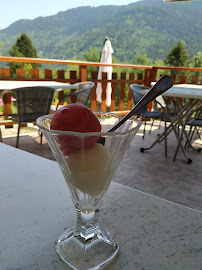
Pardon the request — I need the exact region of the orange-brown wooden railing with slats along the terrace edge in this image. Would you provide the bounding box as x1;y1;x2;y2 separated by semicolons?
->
0;56;202;127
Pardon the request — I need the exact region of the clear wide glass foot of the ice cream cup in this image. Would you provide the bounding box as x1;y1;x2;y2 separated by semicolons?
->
56;226;119;270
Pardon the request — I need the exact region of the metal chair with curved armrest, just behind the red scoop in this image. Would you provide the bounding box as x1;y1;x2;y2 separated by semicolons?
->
52;81;95;111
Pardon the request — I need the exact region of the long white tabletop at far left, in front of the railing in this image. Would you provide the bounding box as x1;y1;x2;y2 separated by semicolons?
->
0;80;78;91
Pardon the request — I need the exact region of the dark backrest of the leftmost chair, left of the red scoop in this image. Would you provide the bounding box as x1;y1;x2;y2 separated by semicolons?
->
12;86;54;122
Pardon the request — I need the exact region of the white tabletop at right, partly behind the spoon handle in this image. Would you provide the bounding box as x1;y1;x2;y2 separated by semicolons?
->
145;83;202;99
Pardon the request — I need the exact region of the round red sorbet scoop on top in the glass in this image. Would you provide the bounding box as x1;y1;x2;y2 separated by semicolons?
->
50;103;101;156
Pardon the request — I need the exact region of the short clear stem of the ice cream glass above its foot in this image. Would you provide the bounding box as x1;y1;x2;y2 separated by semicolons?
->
76;210;99;242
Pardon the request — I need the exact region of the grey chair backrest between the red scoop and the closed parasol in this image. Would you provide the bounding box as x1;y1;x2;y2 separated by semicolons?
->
76;82;95;105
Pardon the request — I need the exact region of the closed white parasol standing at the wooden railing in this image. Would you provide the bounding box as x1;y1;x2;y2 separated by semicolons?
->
96;37;114;106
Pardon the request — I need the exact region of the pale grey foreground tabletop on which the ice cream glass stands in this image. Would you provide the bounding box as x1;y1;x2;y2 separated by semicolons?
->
0;143;202;270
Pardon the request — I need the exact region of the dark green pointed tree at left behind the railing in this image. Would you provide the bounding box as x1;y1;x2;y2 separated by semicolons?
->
9;34;41;76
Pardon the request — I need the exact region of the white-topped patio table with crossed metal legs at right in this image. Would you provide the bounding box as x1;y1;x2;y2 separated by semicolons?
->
140;82;202;163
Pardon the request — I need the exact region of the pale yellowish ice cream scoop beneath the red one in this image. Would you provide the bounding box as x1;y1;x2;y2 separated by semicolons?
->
67;143;113;196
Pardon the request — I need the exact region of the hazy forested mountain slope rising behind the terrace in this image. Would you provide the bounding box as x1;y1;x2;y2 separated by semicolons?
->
0;0;202;63
